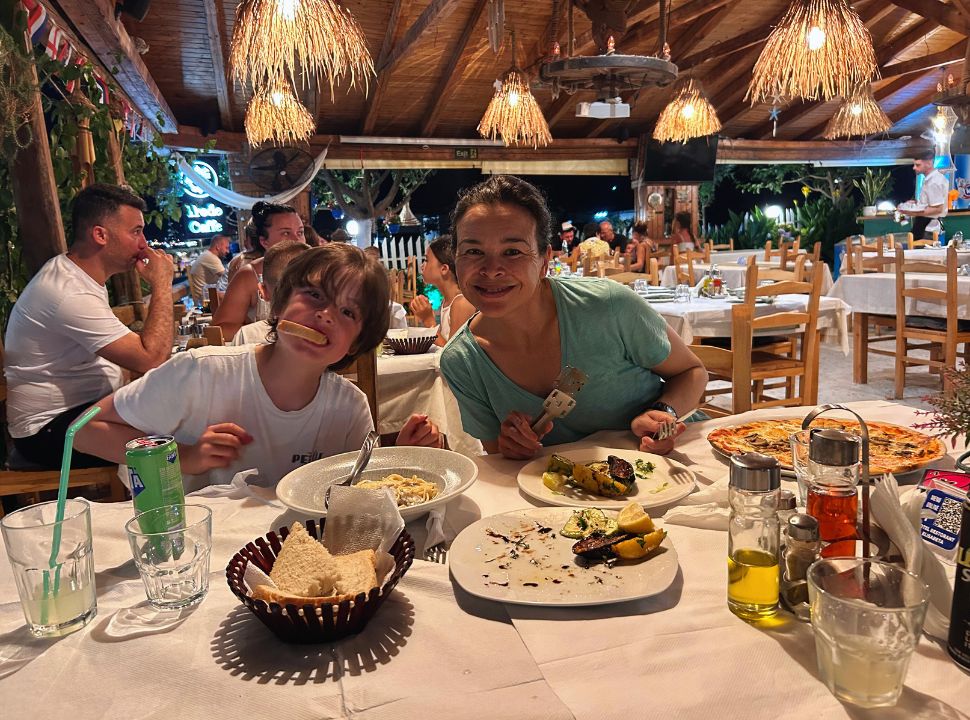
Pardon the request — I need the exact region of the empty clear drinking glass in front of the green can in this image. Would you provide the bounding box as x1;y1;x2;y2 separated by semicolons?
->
125;505;212;610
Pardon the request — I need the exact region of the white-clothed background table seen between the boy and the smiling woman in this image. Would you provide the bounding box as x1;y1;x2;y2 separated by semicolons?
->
377;349;484;456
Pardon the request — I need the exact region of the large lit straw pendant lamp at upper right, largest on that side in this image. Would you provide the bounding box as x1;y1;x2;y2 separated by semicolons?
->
745;0;879;105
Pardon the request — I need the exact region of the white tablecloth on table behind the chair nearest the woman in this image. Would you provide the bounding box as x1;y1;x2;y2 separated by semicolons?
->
650;295;849;355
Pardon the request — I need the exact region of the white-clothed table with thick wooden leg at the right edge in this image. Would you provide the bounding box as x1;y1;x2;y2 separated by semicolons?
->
827;272;970;384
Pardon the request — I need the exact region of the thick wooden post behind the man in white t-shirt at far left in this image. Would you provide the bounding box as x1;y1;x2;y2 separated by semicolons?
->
10;56;67;275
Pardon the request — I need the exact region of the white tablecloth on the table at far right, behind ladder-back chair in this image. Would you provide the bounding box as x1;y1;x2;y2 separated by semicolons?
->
828;273;970;320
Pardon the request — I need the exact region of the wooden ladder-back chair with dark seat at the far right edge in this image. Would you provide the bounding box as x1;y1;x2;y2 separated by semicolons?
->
894;247;970;398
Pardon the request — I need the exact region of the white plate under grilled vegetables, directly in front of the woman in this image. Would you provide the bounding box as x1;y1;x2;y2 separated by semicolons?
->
518;447;697;508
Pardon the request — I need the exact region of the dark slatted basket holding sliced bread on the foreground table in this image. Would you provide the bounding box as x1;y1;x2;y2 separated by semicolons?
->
226;519;414;643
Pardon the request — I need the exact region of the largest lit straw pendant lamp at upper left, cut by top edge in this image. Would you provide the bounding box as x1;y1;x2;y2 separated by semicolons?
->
229;0;376;96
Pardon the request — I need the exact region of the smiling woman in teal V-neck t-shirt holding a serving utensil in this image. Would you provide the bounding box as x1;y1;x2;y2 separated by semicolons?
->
441;175;707;459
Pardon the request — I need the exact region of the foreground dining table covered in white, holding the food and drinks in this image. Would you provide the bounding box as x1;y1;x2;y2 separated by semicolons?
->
0;401;970;720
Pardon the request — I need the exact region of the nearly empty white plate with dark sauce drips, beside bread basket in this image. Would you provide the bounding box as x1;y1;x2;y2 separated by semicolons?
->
448;507;678;607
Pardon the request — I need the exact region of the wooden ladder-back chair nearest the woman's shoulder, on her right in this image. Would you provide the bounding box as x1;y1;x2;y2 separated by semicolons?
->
691;262;822;413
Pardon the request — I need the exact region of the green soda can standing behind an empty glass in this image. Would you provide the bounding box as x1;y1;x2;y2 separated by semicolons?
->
125;435;185;544
